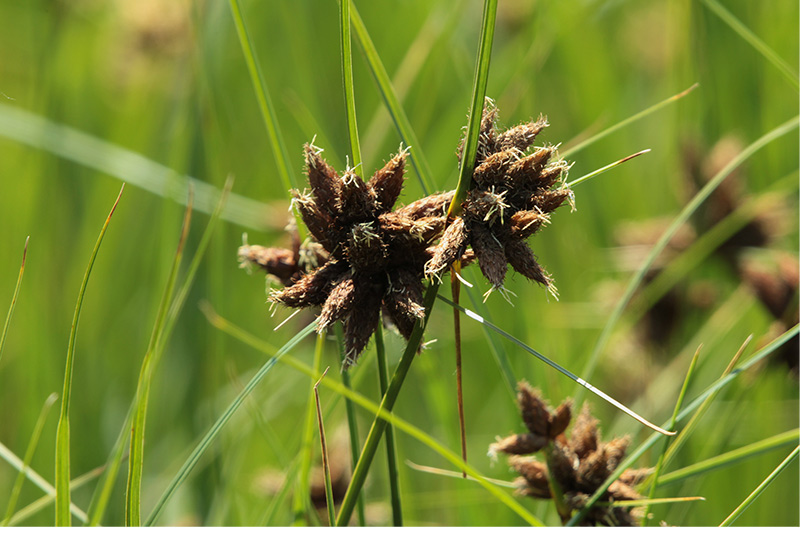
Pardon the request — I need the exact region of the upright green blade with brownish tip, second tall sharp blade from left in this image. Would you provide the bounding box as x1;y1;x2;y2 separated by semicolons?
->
125;190;192;527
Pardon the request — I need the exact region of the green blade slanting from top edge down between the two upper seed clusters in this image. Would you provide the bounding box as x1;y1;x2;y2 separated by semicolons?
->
350;2;436;195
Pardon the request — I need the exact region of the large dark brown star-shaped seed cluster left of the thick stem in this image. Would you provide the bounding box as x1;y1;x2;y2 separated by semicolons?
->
270;145;452;367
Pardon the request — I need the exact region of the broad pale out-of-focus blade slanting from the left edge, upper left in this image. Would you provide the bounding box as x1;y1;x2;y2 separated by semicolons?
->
0;103;269;230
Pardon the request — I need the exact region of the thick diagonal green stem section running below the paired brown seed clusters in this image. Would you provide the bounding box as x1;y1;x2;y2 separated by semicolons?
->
336;283;439;527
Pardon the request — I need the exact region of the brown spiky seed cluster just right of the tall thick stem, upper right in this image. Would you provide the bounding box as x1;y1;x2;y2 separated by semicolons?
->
425;99;572;295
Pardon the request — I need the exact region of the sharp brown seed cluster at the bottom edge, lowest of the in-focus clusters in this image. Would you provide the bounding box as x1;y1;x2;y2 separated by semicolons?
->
489;382;652;526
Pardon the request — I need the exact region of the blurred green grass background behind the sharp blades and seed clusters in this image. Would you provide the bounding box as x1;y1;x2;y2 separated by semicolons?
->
0;0;798;525
